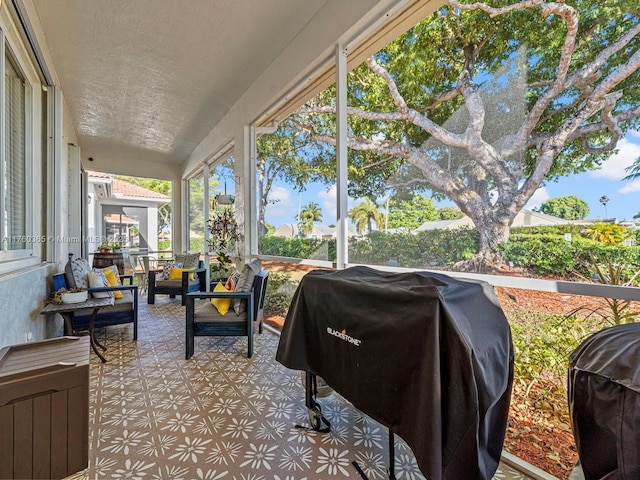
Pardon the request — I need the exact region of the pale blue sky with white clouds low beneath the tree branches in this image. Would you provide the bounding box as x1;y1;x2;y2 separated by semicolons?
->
265;132;640;228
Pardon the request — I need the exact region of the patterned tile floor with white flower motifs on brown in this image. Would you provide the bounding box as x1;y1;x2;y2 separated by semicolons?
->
69;296;528;480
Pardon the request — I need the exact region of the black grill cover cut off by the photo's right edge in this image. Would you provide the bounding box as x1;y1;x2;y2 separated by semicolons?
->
567;323;640;480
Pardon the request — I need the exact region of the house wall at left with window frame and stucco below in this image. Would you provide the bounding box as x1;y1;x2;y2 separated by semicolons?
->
0;2;80;348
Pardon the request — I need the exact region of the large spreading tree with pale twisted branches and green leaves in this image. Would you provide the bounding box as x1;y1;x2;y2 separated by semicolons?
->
293;0;640;268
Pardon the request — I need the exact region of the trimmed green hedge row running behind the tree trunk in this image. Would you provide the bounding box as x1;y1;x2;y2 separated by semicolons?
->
261;226;640;278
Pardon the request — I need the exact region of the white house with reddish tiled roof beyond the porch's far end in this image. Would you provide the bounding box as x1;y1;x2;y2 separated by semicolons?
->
87;171;171;252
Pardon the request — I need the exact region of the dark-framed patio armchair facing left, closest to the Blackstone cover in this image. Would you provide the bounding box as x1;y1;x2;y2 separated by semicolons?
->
185;270;269;359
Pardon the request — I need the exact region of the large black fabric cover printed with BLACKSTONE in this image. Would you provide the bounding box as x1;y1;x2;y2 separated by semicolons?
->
276;267;513;480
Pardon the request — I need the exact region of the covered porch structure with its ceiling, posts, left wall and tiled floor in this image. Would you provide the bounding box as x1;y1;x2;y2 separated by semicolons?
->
0;0;638;480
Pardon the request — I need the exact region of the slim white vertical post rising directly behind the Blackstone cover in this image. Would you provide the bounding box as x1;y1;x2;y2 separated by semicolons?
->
336;44;349;270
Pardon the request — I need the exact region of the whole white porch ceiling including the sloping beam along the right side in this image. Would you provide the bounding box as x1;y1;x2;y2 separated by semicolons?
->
28;0;444;178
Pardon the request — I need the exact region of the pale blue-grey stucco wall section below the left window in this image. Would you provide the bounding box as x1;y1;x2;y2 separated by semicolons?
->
0;264;63;347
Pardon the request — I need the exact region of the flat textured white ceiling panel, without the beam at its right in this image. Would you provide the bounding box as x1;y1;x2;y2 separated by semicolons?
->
33;0;326;165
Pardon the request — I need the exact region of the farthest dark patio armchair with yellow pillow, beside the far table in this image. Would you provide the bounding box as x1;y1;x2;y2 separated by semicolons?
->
147;253;207;305
